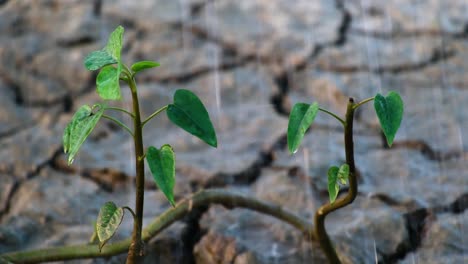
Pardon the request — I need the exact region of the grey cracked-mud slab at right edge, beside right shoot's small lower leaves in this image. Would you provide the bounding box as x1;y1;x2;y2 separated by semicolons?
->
356;148;467;207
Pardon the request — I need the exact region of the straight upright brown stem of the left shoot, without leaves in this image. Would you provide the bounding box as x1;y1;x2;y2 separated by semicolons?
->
126;78;145;264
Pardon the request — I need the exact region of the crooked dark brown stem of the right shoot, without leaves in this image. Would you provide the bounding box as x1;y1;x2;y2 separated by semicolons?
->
314;98;358;264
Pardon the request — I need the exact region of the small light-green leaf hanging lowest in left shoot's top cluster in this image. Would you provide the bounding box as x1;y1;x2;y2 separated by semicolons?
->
96;65;122;100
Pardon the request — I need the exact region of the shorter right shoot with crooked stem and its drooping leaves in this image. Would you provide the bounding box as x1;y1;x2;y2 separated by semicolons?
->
287;91;403;264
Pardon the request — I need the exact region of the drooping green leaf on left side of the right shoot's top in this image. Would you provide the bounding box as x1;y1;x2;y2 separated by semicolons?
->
288;103;319;153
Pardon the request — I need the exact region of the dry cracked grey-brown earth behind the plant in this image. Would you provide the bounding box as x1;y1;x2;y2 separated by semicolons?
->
0;0;468;264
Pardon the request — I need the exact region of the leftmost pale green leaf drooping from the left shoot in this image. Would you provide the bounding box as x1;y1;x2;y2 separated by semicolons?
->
62;104;104;165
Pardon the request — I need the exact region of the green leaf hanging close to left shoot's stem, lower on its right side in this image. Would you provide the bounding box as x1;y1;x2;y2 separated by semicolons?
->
146;145;175;206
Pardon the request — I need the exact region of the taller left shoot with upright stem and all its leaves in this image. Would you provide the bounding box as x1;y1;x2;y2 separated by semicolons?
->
63;26;217;263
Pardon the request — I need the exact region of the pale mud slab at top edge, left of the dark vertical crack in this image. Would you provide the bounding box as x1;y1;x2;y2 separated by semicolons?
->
194;0;341;66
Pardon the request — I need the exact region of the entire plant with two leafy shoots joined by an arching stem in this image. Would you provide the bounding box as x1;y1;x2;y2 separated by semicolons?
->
0;26;403;264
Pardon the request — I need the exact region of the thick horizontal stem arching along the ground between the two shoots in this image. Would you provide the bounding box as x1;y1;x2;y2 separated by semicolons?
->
0;189;315;263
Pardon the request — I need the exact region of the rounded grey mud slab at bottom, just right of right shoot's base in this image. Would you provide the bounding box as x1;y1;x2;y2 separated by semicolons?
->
326;197;408;263
